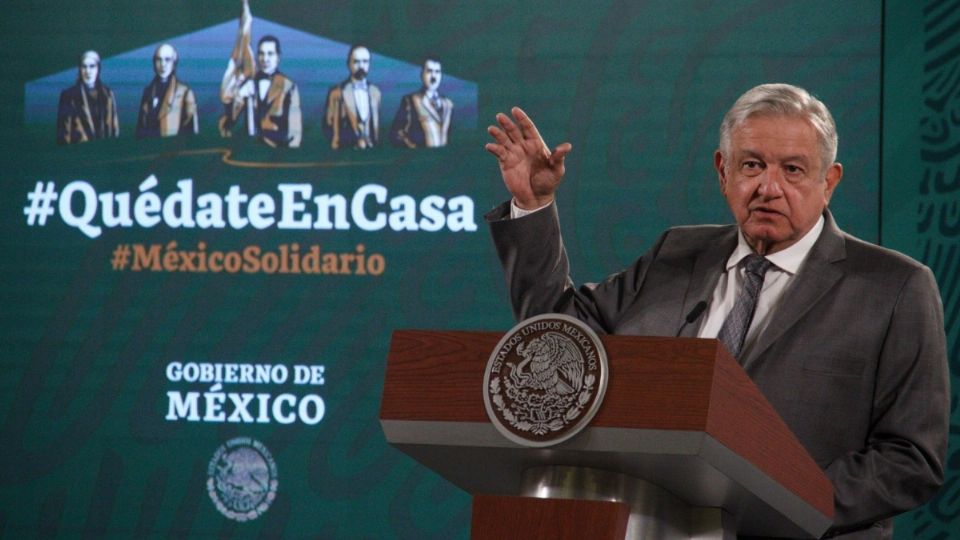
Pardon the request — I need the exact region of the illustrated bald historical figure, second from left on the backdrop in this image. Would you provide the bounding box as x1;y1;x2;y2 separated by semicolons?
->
137;43;199;138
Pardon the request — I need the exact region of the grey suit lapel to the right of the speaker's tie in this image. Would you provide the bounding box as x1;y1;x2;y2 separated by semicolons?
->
741;210;846;368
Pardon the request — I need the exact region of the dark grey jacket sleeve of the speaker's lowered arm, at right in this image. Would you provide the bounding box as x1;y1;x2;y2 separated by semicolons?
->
826;266;950;532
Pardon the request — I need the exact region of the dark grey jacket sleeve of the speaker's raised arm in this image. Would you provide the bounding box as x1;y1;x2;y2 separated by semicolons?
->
485;201;669;333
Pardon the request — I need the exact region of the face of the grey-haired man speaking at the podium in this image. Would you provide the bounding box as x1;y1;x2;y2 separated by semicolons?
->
714;115;843;254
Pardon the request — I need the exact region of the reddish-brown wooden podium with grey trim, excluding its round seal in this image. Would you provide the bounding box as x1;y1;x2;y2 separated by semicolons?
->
380;330;833;539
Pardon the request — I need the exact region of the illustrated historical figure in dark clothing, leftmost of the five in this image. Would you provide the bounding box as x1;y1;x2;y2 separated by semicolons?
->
57;51;120;144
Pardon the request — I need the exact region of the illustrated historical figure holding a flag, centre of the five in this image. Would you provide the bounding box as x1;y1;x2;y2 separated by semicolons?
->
219;0;303;148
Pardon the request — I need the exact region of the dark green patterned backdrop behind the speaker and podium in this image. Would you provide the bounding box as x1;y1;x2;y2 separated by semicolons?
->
0;0;960;539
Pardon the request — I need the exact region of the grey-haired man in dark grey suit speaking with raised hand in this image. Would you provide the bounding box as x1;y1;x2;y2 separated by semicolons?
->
486;85;949;539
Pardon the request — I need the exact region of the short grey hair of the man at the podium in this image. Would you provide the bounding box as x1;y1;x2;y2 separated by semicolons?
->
720;84;837;174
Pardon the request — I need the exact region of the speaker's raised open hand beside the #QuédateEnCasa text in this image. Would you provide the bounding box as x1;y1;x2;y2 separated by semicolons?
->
484;107;573;210
